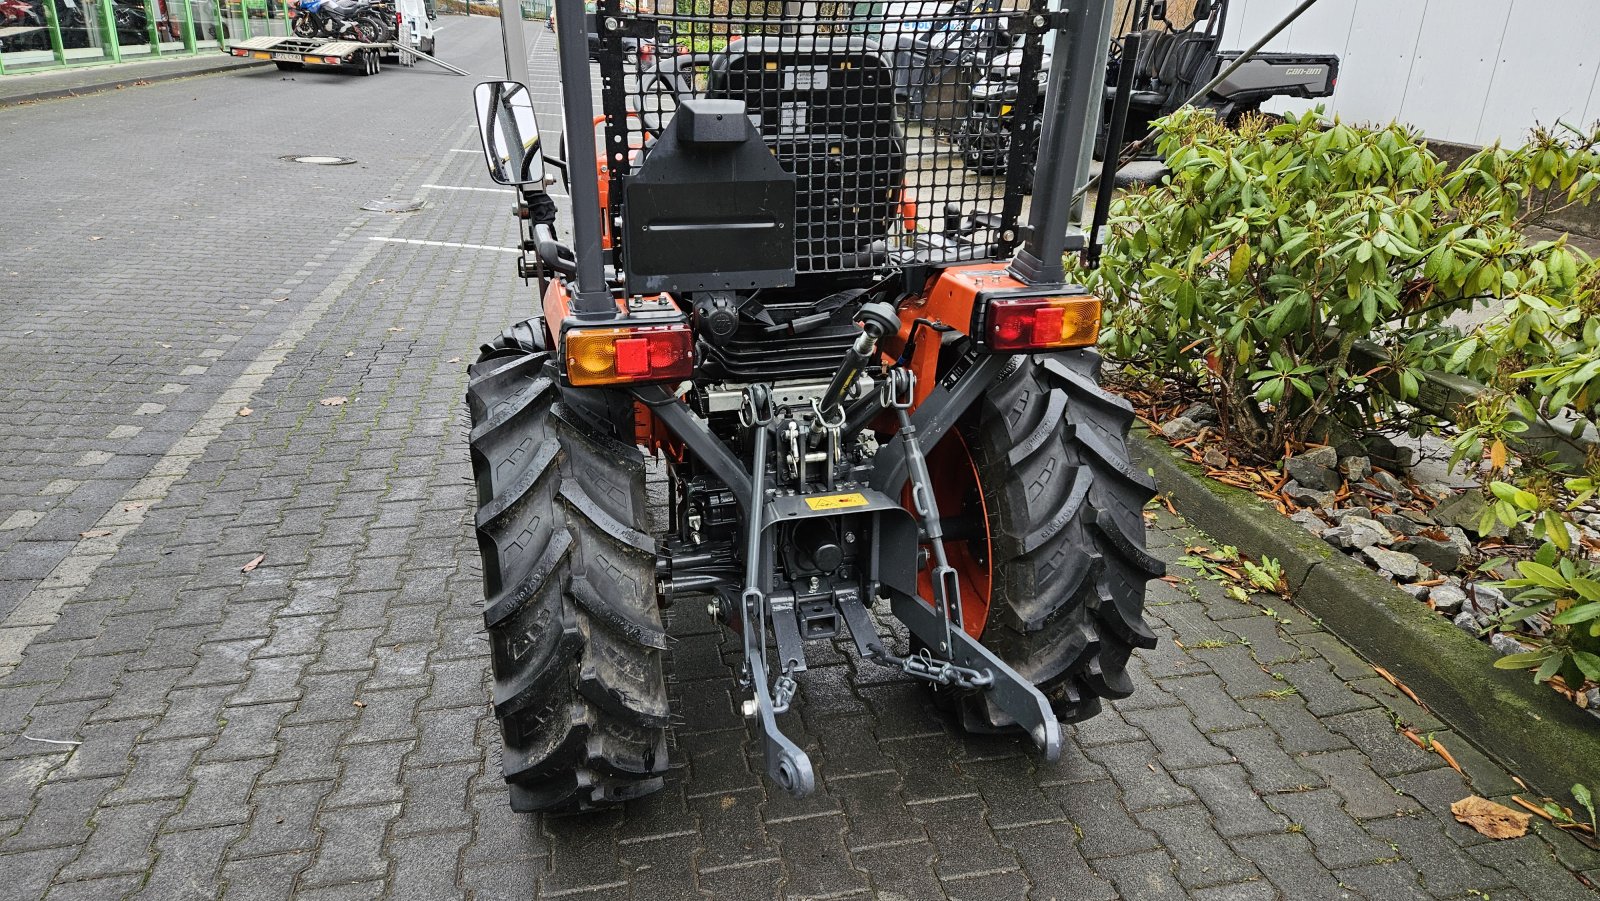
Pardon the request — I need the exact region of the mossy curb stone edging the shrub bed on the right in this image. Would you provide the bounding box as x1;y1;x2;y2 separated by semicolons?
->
1130;427;1600;797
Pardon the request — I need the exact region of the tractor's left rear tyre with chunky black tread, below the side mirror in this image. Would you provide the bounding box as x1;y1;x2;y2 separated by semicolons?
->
467;334;669;813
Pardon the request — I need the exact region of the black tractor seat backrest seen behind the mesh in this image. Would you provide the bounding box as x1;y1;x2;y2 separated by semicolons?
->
706;35;906;274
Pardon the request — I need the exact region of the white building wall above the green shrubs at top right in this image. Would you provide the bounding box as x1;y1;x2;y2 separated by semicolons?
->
1222;0;1600;144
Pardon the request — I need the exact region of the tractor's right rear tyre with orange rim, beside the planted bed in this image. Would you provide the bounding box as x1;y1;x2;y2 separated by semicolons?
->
930;350;1165;731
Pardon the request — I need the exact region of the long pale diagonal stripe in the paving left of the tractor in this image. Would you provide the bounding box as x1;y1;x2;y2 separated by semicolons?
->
0;127;473;677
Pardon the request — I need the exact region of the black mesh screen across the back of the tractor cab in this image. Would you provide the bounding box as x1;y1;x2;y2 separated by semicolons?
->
595;0;1046;280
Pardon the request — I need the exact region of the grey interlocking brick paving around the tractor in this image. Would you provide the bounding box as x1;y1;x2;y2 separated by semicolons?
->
0;19;1600;901
